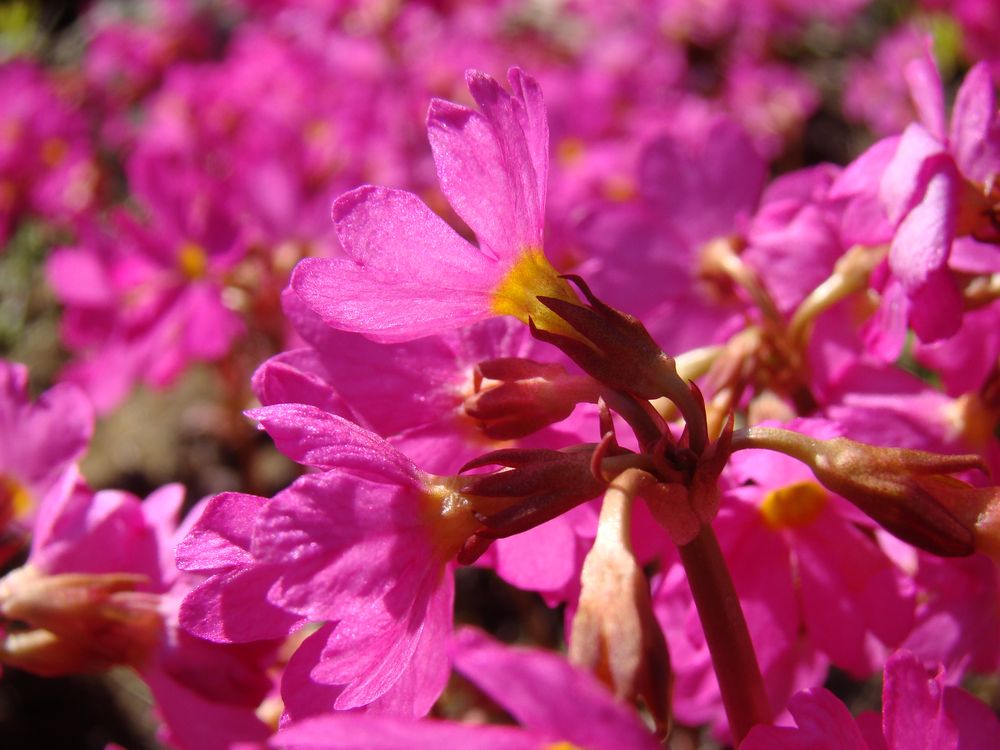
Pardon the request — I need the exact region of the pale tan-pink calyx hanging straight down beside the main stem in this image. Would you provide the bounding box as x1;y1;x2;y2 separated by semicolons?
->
569;469;671;732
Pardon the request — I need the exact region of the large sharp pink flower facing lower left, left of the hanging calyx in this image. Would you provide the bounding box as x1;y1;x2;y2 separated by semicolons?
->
179;412;478;716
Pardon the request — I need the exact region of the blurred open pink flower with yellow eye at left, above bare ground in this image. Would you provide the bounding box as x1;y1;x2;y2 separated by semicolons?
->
46;152;244;411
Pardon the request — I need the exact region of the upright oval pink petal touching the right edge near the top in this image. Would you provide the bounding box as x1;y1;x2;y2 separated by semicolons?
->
951;62;1000;184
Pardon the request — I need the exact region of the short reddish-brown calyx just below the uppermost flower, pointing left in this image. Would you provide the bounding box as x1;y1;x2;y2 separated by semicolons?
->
464;357;600;440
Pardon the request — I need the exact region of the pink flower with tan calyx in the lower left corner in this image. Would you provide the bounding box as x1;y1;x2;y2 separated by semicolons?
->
0;485;275;750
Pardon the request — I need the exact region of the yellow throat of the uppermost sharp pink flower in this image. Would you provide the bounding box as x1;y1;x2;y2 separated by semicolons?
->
492;249;580;338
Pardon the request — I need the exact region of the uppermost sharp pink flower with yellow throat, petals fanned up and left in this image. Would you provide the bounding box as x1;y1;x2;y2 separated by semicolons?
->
292;68;576;342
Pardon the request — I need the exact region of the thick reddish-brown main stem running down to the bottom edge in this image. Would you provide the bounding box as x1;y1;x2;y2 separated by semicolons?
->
680;524;771;746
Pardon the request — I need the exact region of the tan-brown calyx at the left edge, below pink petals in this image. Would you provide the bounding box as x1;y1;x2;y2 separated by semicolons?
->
0;566;163;676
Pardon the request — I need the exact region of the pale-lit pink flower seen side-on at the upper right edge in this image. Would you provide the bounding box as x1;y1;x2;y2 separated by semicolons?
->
879;53;1000;357
